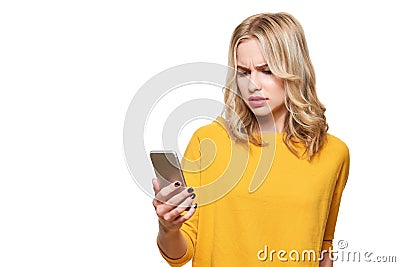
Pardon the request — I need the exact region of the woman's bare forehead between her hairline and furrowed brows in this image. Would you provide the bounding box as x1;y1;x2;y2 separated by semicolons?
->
236;38;266;66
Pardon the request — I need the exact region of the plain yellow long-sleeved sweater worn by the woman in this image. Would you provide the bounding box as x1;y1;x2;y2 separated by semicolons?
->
160;117;349;267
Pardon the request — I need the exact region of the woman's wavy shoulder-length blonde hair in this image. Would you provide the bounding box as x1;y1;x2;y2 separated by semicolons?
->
224;13;328;160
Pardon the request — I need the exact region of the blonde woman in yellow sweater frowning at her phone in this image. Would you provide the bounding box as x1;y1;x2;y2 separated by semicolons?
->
153;13;349;267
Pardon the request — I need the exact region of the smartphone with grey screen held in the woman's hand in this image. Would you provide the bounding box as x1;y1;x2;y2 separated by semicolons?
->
150;150;186;189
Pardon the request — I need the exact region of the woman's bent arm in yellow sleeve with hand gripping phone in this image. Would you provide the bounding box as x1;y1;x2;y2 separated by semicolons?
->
153;134;200;266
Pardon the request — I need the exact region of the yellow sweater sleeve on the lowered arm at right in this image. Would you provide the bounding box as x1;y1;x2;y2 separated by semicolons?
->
321;146;350;251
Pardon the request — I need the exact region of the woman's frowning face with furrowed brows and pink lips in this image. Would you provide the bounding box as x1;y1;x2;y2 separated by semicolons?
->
237;38;287;119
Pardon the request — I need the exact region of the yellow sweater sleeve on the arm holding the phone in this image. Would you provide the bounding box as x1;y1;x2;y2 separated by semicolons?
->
159;133;201;267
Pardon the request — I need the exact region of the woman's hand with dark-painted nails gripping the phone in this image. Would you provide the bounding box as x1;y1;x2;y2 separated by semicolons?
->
152;179;197;232
